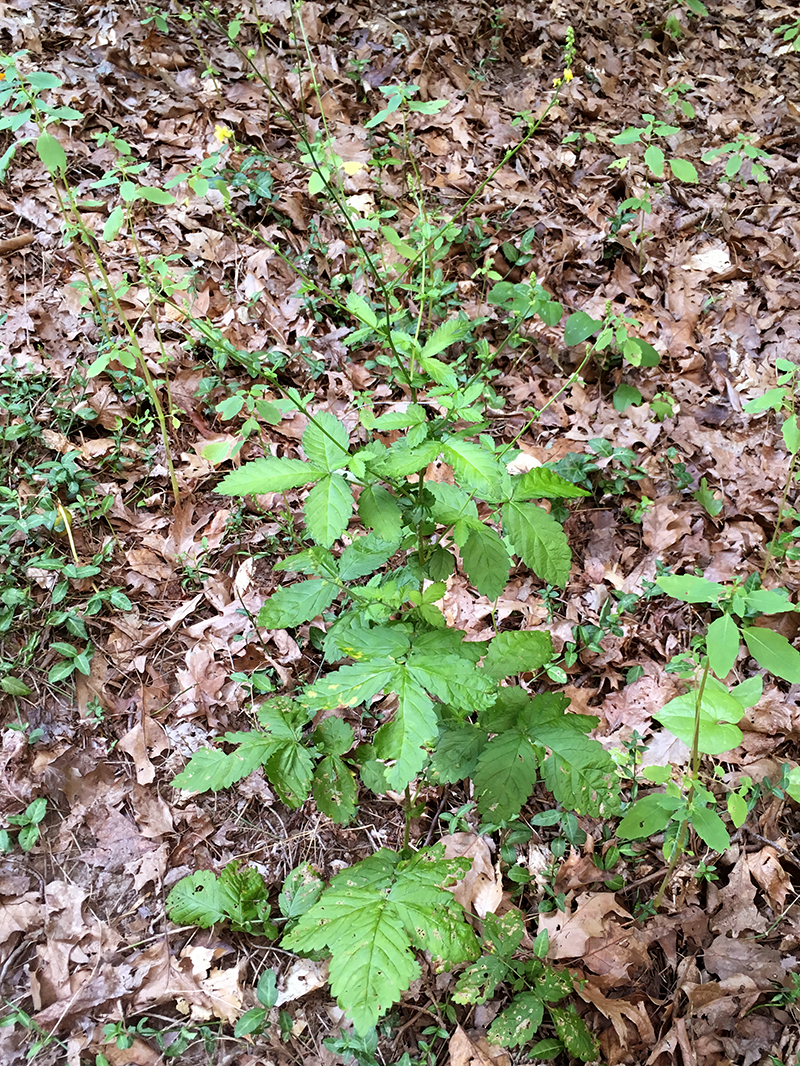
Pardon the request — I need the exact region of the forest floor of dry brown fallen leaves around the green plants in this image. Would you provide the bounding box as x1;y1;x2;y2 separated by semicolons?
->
0;0;800;1066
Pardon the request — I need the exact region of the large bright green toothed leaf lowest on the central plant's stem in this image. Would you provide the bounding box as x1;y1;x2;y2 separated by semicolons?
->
282;844;478;1035
